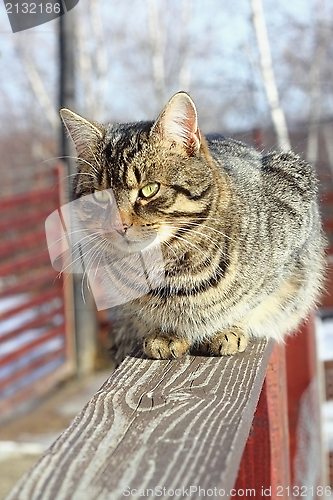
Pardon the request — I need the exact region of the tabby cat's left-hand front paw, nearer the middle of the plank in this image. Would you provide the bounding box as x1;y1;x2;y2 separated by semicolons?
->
143;333;191;359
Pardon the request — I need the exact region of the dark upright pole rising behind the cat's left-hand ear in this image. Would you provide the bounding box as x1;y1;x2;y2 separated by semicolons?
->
59;10;97;376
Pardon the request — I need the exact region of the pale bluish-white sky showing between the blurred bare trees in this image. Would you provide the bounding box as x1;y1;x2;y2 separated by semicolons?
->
0;0;330;134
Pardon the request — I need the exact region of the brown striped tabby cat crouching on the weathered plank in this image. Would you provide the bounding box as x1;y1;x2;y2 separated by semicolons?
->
61;92;324;360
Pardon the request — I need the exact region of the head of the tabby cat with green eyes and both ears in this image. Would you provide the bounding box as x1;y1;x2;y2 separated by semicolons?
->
61;92;216;258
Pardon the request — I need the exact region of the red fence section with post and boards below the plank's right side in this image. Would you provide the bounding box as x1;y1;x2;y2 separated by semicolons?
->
235;318;322;492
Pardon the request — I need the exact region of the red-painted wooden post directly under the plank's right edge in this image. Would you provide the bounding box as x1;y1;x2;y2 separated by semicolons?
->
234;345;290;499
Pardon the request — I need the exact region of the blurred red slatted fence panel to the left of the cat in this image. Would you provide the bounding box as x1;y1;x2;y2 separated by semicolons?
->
0;166;73;422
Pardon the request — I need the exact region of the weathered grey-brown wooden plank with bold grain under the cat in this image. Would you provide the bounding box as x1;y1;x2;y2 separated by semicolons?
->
7;340;273;500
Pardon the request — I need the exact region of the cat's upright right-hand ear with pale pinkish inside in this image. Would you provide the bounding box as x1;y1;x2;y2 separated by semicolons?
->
151;92;201;156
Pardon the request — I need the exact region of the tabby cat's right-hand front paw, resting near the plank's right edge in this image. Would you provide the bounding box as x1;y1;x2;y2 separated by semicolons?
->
207;327;248;356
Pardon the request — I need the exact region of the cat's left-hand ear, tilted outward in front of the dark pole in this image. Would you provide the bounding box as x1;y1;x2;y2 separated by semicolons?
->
60;108;104;155
